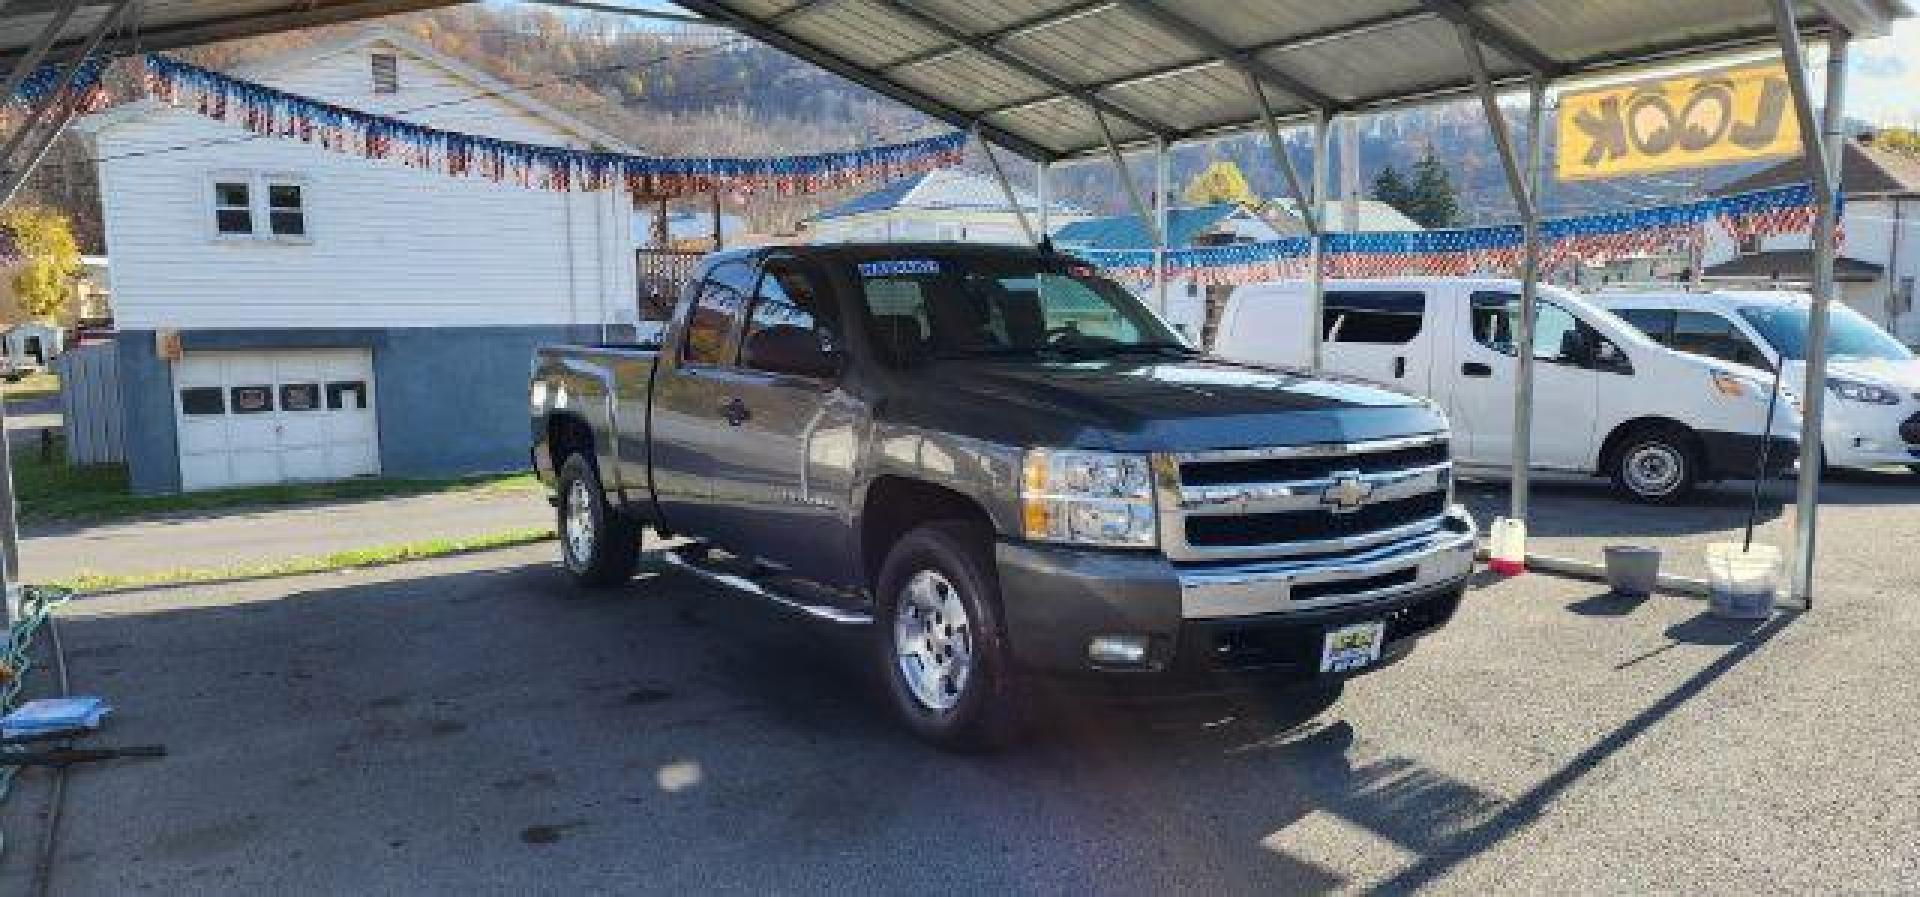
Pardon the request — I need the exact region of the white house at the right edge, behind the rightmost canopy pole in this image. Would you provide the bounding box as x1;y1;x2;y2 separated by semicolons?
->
1701;136;1920;344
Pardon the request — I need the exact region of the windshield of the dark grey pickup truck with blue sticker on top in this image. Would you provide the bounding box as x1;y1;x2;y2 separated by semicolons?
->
856;255;1194;363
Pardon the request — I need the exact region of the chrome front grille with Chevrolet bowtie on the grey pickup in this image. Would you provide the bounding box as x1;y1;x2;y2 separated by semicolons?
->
1156;434;1453;561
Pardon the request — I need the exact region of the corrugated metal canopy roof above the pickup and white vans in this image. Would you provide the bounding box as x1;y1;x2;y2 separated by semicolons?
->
678;0;1908;159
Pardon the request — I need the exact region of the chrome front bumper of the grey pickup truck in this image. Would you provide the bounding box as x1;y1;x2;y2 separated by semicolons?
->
1179;505;1478;620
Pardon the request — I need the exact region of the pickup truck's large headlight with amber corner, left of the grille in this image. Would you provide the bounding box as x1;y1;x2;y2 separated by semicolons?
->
1020;449;1158;547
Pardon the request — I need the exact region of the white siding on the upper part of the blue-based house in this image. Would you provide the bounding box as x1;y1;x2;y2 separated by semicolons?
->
96;39;634;328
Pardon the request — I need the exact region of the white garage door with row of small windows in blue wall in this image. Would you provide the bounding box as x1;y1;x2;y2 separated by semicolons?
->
173;350;380;490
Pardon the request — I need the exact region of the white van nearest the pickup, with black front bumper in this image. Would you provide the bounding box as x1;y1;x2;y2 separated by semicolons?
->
1213;277;1799;503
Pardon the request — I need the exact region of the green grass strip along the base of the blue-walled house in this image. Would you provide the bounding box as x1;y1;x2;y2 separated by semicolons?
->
13;446;540;522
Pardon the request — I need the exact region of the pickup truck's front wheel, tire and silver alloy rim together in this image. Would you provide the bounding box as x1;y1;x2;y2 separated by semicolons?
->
874;521;1023;751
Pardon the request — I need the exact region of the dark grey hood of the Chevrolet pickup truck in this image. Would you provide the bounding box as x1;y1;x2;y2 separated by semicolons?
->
881;357;1446;451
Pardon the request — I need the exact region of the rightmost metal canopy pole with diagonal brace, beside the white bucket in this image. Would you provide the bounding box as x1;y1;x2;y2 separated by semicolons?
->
1768;0;1847;609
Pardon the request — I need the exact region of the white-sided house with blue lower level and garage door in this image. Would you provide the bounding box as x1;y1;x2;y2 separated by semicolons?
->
81;29;634;492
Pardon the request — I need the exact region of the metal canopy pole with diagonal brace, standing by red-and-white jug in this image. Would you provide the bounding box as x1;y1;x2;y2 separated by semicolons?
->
1455;25;1546;521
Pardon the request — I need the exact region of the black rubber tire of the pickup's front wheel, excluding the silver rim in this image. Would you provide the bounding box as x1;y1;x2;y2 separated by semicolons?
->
874;521;1025;751
